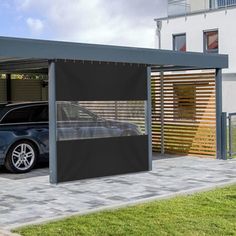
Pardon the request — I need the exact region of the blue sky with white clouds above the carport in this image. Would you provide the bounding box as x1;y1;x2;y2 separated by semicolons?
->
0;0;167;48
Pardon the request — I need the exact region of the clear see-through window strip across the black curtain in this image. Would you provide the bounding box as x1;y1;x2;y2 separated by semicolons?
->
57;101;146;141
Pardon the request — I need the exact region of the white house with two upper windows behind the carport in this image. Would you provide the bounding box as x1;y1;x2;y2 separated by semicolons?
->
155;0;236;112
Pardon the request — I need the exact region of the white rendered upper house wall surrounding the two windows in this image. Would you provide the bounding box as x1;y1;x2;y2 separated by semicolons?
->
161;8;236;73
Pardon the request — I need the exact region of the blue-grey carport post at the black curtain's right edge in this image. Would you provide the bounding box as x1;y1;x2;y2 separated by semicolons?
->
146;67;152;170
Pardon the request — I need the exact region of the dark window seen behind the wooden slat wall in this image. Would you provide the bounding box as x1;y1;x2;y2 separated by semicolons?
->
174;84;196;120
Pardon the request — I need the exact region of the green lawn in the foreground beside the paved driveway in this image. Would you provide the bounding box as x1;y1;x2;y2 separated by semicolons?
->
15;185;236;236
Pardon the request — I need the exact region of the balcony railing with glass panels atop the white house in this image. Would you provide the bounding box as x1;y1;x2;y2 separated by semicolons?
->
168;0;236;16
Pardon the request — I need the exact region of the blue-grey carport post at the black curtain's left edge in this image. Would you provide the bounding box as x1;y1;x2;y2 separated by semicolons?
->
48;62;57;184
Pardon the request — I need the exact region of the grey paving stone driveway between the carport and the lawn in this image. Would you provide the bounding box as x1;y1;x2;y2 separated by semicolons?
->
0;157;236;229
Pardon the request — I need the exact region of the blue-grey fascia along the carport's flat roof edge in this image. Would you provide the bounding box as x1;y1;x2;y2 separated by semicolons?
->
0;37;228;69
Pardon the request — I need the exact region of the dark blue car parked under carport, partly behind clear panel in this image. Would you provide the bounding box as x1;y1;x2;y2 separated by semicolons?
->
0;102;142;173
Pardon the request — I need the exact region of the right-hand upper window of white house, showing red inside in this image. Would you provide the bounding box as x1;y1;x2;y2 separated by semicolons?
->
204;30;219;53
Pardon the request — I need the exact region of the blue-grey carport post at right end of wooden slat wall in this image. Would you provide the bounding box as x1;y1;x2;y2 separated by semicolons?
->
216;69;222;159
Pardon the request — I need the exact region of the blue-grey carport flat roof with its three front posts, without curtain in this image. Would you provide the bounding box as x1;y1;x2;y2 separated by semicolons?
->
0;37;228;183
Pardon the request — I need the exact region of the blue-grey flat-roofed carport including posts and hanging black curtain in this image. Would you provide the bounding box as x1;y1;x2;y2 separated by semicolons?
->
0;37;228;183
